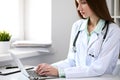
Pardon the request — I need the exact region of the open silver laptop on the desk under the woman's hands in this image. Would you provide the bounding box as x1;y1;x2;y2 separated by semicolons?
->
10;52;56;80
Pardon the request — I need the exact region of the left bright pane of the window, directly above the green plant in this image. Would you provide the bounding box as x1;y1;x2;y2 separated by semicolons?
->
0;0;23;38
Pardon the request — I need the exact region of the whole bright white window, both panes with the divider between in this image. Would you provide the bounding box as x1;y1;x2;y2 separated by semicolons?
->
0;0;51;43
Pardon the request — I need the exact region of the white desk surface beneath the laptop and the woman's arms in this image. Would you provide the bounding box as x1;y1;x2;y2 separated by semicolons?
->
0;72;120;80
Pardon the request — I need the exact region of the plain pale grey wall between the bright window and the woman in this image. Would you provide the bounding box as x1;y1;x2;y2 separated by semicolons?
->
21;0;79;65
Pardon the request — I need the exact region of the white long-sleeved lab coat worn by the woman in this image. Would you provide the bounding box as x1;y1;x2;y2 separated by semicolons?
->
54;19;120;78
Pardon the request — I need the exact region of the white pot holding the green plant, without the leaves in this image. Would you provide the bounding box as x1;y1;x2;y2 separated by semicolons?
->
0;41;10;54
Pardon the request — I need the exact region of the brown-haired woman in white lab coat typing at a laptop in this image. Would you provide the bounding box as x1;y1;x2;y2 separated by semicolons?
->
36;0;120;78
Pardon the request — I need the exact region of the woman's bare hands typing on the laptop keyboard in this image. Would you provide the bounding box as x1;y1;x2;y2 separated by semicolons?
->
36;63;58;77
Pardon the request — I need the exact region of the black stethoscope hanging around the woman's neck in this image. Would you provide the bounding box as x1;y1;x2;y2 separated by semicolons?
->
73;21;109;57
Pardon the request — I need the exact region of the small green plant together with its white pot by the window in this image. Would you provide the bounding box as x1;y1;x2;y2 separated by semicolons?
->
0;31;11;53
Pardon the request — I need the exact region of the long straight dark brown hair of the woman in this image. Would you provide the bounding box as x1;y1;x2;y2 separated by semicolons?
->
75;0;114;22
